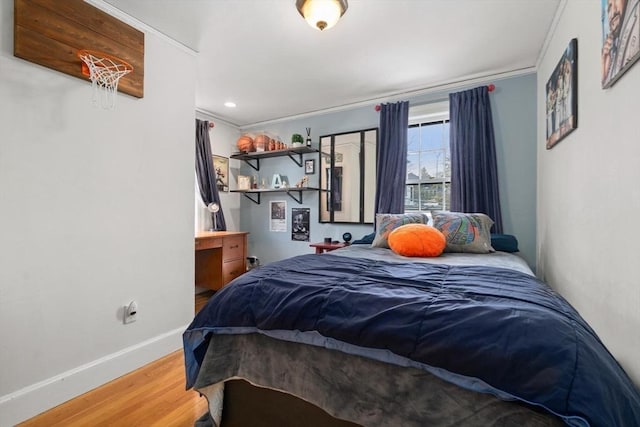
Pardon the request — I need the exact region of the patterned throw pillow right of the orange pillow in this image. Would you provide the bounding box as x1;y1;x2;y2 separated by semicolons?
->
433;212;495;254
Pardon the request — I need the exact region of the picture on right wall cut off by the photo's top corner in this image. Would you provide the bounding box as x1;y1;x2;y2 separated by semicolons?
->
600;0;640;89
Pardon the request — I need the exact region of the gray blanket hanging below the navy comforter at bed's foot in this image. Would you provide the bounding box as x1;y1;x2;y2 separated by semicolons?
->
194;334;564;427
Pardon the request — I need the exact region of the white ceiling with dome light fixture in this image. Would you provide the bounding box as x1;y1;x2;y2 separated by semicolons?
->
104;0;561;127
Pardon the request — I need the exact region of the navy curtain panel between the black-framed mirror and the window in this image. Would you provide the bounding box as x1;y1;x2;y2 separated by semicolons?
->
375;101;409;213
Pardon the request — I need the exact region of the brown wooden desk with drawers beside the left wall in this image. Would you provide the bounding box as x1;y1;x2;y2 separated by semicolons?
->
195;231;249;291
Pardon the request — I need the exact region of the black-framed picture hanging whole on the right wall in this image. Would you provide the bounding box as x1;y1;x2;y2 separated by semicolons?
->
546;39;578;150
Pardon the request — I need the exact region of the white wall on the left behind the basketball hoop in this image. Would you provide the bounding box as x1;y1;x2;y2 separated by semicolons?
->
0;1;195;426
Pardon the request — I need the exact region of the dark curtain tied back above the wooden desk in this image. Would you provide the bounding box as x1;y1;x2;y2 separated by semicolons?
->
196;119;227;231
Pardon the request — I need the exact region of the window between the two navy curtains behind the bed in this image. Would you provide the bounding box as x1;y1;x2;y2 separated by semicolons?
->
404;102;451;212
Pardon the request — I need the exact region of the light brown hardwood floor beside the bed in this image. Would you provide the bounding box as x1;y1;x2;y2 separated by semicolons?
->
18;292;218;427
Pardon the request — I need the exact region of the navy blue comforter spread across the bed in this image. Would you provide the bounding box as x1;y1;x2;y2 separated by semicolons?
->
184;254;640;427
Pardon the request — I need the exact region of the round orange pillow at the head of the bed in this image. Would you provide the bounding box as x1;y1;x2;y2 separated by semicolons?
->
388;224;447;257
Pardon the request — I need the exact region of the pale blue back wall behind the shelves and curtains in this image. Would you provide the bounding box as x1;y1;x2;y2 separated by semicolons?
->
240;74;536;266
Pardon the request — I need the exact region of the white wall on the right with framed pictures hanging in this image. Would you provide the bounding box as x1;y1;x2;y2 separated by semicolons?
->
537;0;640;384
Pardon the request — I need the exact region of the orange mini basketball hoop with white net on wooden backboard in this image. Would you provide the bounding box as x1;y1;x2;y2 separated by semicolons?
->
78;49;133;110
